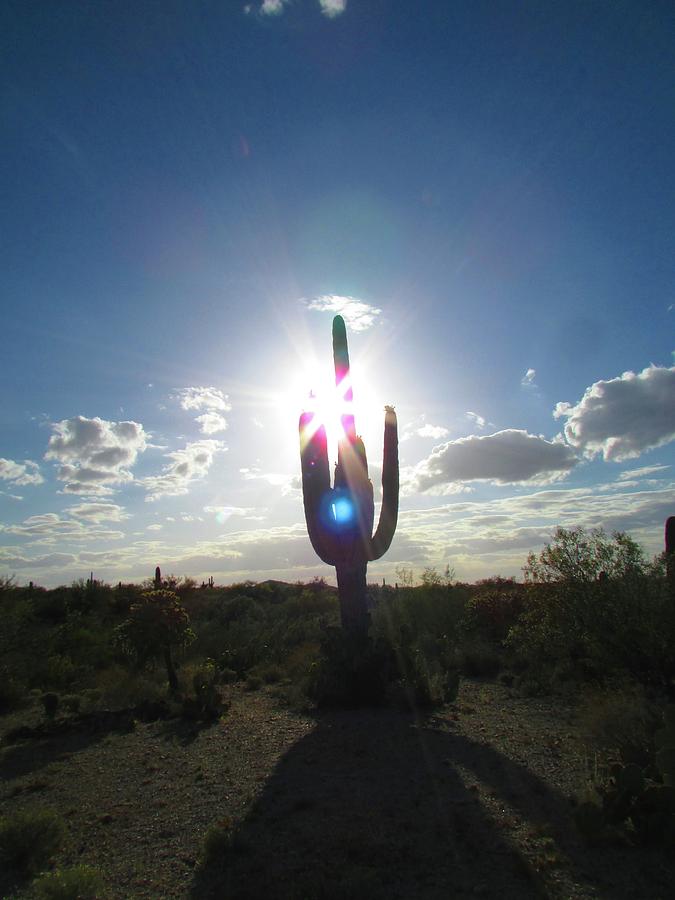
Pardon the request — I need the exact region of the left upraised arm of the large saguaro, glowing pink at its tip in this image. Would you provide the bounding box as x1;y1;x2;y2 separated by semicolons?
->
300;412;335;566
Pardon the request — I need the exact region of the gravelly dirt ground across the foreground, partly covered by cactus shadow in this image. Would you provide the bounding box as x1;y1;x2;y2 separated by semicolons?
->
0;680;675;900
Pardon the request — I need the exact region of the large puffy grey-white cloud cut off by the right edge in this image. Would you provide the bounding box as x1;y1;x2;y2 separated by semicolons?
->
553;366;675;462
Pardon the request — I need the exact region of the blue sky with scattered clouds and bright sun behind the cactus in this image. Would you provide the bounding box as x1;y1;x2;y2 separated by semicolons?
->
0;0;675;585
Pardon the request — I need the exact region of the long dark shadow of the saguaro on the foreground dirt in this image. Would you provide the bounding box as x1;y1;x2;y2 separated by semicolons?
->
191;710;672;900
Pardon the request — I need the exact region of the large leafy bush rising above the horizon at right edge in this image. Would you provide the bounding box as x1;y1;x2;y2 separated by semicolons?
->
506;528;675;687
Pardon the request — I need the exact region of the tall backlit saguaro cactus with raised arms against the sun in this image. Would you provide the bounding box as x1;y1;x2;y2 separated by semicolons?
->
300;316;398;634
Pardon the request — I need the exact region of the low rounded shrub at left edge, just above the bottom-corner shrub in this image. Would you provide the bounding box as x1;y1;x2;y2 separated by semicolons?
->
0;809;65;877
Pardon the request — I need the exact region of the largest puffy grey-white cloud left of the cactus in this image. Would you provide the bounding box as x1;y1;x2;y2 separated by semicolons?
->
45;416;148;494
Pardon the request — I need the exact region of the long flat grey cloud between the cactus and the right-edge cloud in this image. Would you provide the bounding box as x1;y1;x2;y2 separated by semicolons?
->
414;428;577;491
